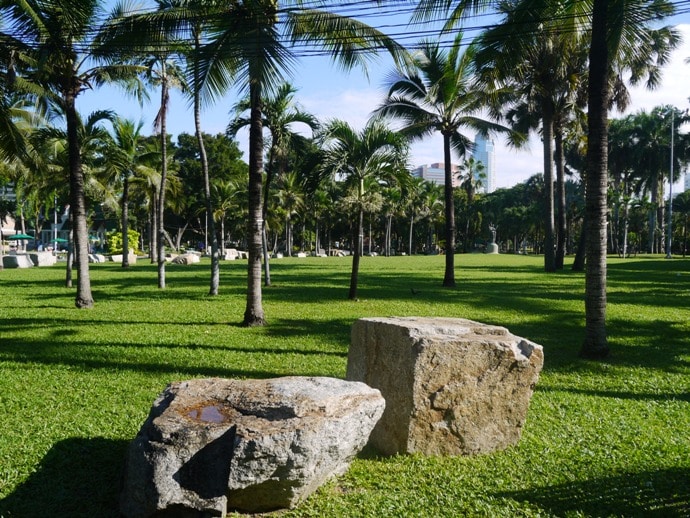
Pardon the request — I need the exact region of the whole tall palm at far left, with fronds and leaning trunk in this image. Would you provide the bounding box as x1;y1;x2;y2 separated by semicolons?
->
0;0;144;308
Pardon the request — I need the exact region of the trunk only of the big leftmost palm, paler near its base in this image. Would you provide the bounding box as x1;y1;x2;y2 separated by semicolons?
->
65;94;93;308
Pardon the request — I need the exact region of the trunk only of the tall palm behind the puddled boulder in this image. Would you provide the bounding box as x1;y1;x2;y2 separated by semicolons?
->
243;78;266;326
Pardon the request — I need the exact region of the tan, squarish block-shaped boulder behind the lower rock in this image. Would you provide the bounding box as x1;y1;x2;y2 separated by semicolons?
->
347;317;544;455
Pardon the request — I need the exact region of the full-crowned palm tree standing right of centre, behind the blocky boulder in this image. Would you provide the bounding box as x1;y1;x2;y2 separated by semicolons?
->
377;33;521;287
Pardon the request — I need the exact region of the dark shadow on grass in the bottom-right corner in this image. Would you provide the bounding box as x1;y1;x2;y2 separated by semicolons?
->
494;468;690;517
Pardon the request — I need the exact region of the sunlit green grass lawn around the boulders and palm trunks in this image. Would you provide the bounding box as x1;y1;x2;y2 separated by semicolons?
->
0;255;690;518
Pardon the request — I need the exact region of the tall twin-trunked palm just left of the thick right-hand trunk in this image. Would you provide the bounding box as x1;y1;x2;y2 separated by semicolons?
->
477;0;588;272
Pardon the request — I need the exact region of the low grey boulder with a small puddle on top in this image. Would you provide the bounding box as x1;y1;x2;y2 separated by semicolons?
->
121;377;385;517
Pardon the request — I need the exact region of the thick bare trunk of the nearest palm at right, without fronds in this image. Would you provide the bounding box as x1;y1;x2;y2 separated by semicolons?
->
580;0;609;358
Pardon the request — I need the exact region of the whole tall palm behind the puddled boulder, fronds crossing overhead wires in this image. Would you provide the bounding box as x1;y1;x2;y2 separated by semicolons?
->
196;0;402;326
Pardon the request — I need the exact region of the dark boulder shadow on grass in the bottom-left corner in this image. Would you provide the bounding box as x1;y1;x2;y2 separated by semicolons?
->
0;437;128;518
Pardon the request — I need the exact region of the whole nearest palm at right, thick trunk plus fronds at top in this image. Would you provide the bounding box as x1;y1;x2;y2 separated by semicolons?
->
580;0;678;358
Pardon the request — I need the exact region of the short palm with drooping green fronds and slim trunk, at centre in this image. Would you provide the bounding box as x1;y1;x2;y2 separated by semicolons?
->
321;118;409;300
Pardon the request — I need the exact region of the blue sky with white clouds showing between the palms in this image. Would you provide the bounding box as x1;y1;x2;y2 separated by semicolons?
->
77;4;690;192
